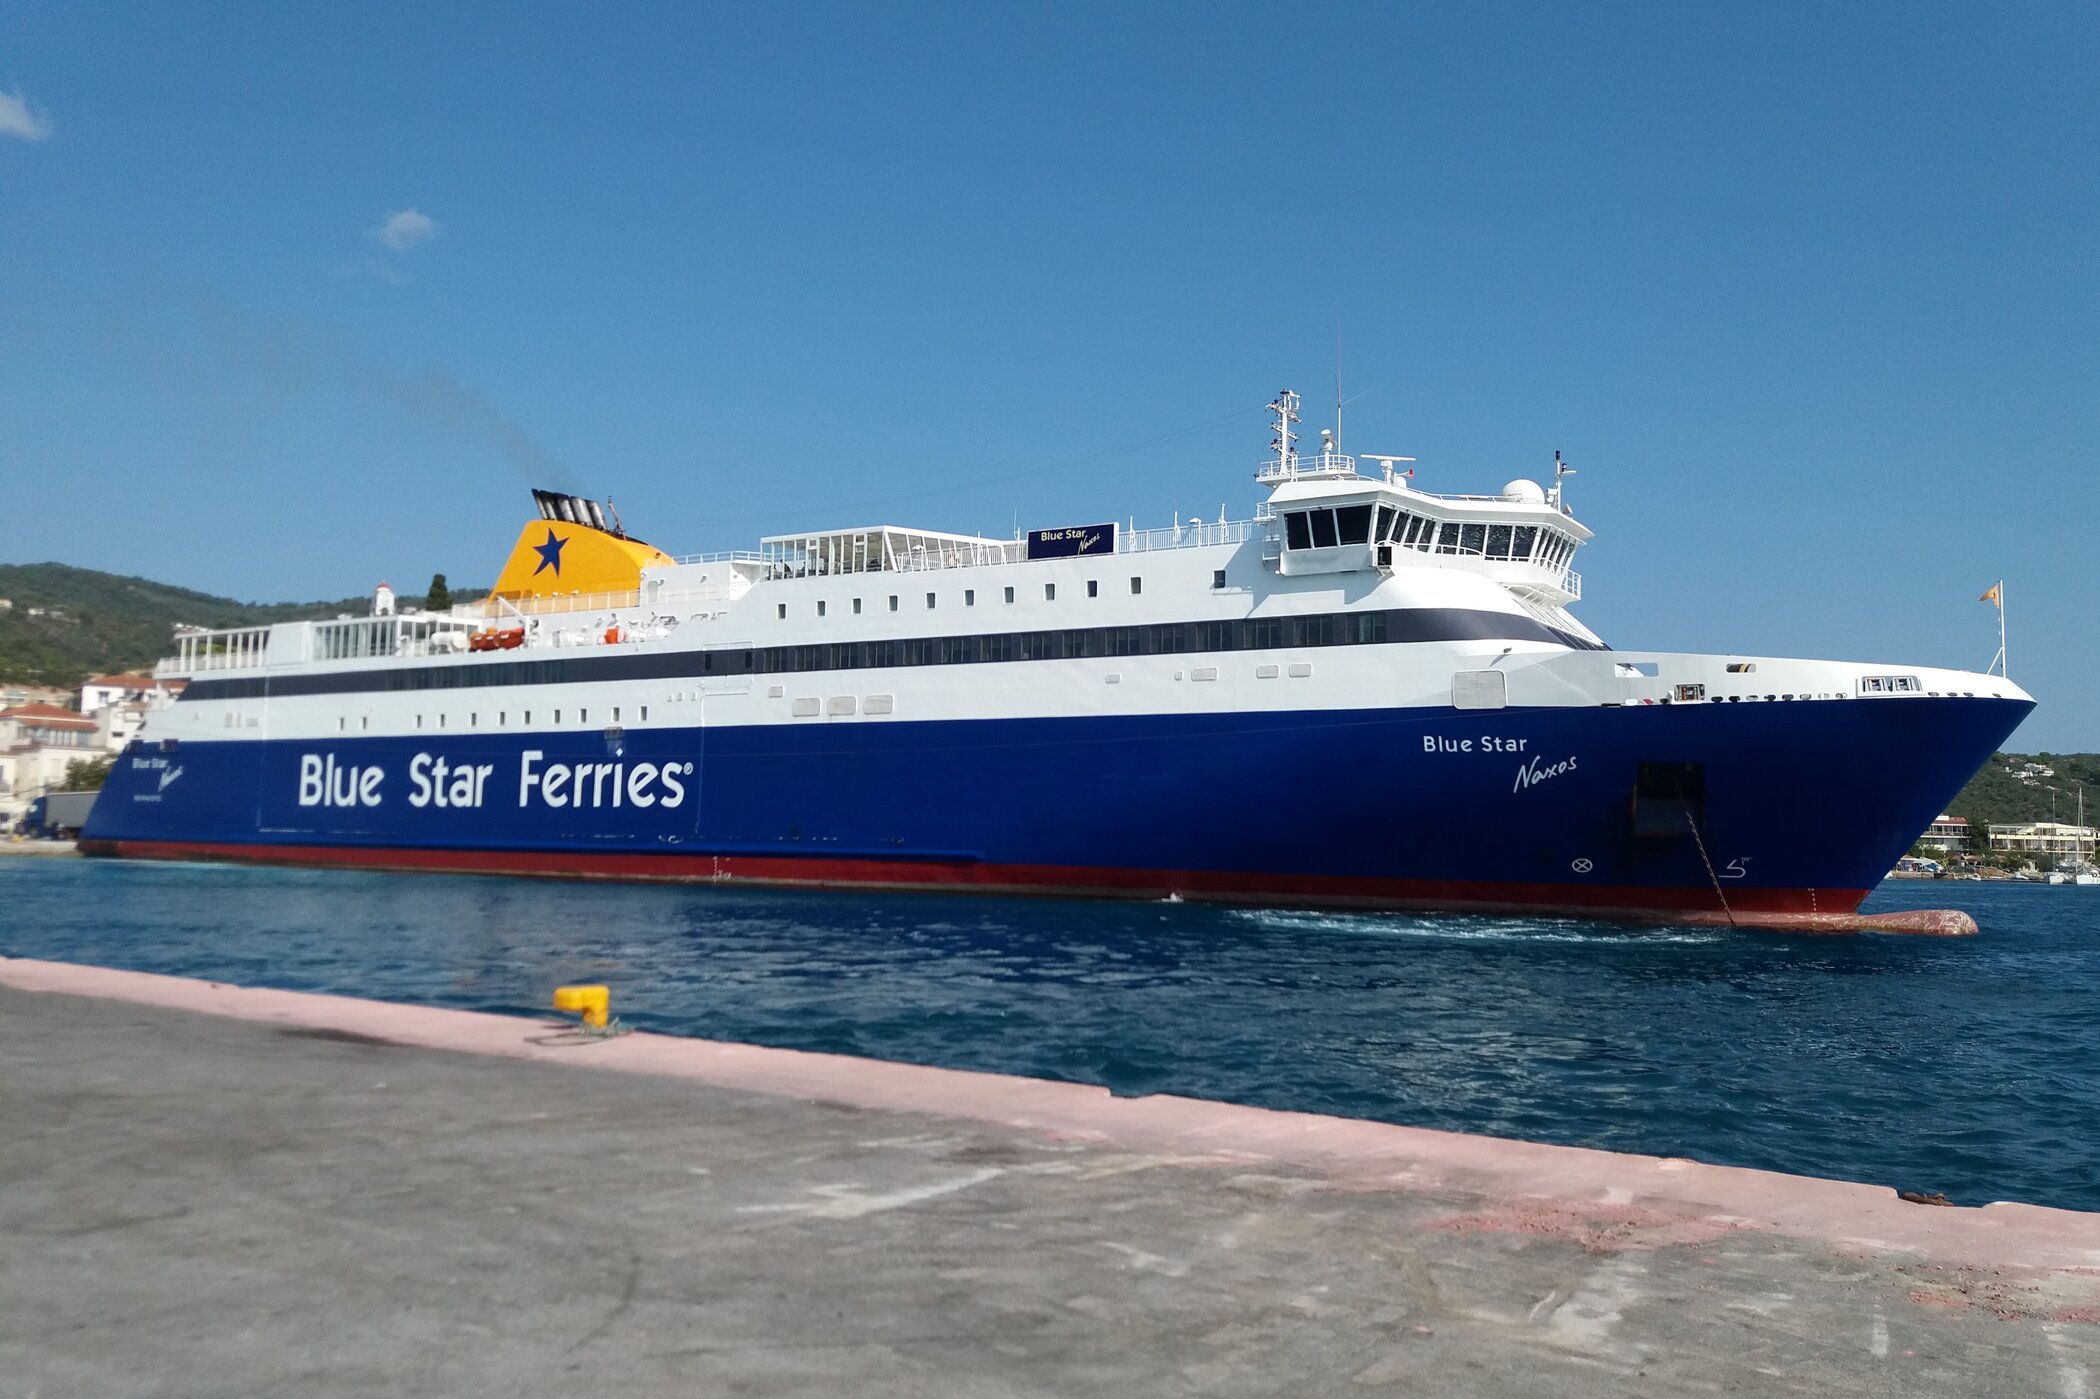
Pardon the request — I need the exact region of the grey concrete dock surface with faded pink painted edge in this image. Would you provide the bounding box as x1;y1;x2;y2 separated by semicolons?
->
0;958;2100;1399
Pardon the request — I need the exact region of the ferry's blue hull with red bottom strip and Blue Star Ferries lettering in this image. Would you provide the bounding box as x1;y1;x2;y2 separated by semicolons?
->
82;697;2033;924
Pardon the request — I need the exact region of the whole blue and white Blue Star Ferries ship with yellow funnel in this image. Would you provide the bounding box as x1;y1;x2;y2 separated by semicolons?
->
82;393;2033;926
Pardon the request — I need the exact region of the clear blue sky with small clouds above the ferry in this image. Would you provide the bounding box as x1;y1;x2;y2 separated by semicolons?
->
0;0;2100;750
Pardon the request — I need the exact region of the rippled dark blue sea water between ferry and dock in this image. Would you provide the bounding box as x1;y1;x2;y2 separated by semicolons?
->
0;859;2100;1210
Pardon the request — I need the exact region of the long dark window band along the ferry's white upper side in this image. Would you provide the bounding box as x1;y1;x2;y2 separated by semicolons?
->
183;607;1602;702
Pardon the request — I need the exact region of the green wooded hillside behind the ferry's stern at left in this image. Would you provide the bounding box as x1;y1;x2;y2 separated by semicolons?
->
0;563;477;687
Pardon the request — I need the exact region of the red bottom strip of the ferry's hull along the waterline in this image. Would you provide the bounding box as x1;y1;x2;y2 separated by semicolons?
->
61;840;1931;933
